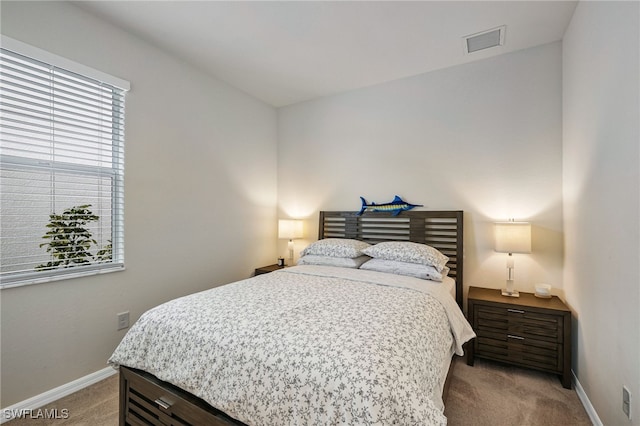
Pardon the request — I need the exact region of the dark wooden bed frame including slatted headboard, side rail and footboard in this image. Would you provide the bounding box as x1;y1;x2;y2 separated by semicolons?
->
119;211;463;426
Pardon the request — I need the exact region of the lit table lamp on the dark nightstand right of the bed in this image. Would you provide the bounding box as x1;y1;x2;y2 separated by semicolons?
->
495;221;531;297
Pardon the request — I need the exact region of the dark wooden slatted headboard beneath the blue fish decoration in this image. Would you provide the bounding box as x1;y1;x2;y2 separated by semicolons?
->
318;210;464;309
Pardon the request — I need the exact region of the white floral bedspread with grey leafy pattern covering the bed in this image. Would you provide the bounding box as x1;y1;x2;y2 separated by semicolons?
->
109;265;473;426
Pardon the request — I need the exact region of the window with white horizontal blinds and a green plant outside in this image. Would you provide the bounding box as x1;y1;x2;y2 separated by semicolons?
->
0;36;129;287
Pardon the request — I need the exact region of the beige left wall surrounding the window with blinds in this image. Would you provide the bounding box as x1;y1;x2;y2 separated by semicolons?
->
0;1;276;407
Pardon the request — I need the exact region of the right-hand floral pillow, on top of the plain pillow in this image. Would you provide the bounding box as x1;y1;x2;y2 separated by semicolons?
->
362;241;449;271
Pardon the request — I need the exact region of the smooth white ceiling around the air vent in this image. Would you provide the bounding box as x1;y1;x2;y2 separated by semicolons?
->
74;1;577;107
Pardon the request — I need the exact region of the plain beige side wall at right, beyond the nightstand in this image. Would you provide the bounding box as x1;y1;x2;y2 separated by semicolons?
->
563;2;640;425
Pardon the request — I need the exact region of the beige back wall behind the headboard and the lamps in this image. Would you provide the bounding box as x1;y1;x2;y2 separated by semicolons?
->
278;43;562;298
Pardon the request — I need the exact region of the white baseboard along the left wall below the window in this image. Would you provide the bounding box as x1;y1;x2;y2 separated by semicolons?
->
0;367;117;424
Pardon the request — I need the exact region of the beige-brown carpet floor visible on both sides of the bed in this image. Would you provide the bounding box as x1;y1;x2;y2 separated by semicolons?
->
5;357;591;426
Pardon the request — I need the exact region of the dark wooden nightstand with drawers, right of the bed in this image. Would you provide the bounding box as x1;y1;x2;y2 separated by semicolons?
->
467;287;571;389
